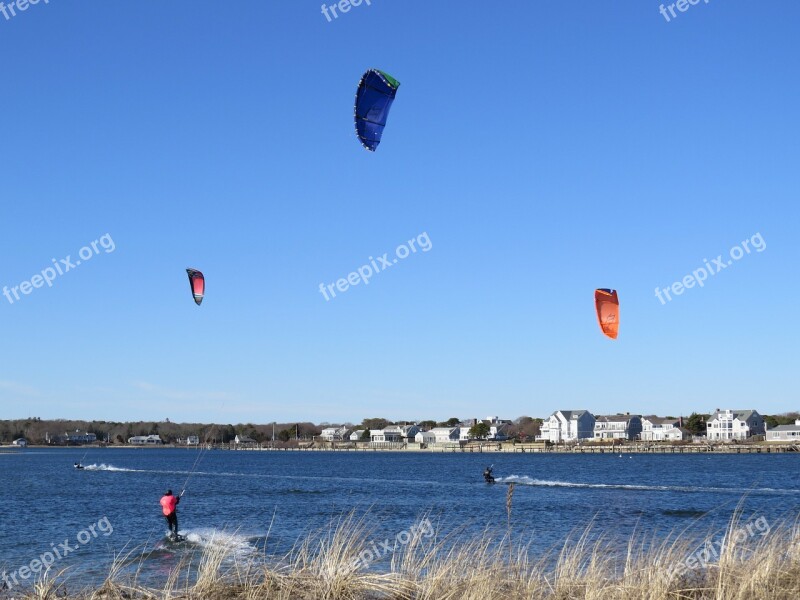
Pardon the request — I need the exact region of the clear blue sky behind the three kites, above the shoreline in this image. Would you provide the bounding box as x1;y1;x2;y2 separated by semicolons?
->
0;0;800;423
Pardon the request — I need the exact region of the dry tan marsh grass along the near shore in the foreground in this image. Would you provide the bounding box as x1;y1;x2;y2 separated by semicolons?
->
10;508;800;600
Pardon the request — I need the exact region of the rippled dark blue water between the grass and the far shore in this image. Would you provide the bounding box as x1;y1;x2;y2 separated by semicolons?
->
0;449;800;584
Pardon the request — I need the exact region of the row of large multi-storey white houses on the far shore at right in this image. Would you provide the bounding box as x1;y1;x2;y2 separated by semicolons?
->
537;409;800;443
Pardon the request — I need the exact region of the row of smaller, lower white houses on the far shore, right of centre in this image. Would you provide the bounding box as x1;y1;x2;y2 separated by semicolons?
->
320;417;511;445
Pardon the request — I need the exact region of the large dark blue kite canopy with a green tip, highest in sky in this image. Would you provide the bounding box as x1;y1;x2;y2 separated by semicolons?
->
355;69;400;152
